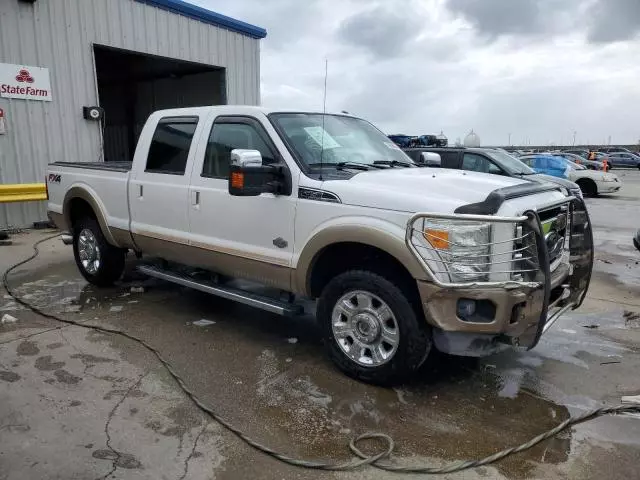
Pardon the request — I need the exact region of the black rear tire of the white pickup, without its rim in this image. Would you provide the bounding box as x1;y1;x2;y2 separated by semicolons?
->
73;217;126;287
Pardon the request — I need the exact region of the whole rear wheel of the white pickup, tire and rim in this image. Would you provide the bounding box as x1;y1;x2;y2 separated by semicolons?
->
73;217;126;287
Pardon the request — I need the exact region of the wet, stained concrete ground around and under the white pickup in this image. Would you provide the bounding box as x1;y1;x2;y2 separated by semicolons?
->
0;170;640;480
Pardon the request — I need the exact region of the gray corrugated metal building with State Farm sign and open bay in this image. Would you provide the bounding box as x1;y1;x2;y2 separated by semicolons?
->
0;0;266;229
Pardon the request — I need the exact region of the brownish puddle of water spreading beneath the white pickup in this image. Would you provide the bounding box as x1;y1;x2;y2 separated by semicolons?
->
6;262;640;477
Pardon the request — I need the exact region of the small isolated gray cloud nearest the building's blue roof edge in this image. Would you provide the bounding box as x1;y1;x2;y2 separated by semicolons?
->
337;3;419;58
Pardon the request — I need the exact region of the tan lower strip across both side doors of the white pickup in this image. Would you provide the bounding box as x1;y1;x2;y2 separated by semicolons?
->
133;234;291;291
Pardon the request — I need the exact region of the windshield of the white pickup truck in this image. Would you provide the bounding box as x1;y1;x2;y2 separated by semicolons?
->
269;113;414;169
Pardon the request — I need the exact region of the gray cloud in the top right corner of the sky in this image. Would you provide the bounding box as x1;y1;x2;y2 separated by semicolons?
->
587;0;640;43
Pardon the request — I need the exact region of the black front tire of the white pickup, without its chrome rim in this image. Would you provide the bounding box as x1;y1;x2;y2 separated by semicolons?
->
317;270;431;386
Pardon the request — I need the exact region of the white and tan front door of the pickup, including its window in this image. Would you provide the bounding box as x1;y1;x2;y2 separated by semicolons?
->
189;116;296;289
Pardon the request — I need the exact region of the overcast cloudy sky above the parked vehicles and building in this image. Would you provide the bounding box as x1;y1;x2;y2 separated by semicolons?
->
191;0;640;144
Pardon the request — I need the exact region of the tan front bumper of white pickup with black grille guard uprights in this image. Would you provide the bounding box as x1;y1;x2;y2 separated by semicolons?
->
410;199;593;356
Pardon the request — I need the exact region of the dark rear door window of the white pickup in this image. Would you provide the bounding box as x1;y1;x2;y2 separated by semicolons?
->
145;117;198;175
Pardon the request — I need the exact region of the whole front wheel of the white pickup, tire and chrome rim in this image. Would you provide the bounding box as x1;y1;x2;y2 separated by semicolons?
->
318;270;431;385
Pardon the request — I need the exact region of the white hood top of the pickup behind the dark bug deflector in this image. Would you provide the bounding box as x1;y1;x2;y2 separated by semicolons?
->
322;168;528;213
